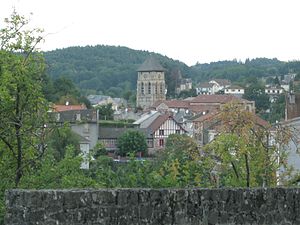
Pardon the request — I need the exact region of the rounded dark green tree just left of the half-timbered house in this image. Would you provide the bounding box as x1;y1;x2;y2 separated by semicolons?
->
117;130;147;156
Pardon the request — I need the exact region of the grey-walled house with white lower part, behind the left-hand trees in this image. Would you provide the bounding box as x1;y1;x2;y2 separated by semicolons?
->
50;109;99;169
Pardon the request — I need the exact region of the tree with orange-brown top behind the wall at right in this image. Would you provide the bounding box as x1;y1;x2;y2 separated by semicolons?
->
204;104;291;187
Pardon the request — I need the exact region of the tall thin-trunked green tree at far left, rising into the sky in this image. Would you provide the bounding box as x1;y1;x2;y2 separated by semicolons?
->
0;12;48;187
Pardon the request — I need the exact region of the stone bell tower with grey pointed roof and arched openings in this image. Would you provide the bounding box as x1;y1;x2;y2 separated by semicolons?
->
136;56;166;109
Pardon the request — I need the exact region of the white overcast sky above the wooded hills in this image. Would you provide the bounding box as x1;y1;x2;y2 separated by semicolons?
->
0;0;300;65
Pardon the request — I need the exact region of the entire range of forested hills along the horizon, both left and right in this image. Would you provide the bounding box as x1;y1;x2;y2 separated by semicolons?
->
44;45;300;99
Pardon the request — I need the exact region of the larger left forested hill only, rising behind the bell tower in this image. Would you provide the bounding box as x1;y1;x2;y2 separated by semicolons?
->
44;45;192;97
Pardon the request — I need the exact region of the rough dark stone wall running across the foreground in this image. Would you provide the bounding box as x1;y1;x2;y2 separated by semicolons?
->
6;188;300;225
